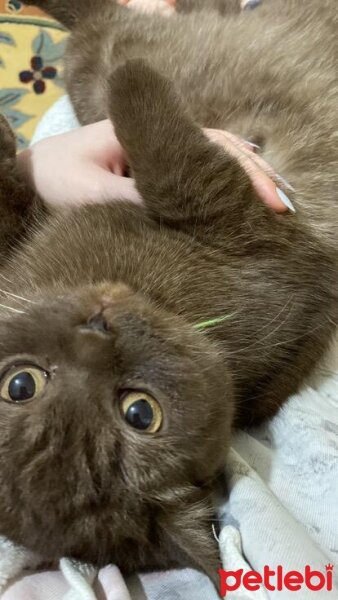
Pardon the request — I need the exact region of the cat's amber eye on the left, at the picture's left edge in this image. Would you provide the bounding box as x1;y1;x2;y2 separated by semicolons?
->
0;365;48;404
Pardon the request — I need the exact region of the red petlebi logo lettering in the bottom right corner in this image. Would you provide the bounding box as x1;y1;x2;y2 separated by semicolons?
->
218;564;333;600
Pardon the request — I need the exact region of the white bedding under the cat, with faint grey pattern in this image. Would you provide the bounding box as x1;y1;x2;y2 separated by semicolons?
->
0;97;338;600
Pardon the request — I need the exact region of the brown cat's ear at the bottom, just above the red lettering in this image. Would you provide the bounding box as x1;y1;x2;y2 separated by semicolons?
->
160;496;221;589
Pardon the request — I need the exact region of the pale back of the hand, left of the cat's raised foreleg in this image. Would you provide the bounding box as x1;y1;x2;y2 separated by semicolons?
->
18;120;142;208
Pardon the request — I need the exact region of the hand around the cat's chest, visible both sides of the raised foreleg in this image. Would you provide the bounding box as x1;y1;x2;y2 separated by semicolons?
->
18;120;293;212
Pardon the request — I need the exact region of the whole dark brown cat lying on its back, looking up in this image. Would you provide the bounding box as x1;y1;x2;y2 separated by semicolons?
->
0;0;338;585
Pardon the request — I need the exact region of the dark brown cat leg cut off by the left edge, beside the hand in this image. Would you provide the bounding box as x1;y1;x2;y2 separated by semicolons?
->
0;114;42;268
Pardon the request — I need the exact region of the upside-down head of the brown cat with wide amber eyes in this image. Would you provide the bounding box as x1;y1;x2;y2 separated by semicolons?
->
0;284;232;574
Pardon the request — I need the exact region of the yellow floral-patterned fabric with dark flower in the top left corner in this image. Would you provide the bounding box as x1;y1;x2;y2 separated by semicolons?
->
0;0;67;148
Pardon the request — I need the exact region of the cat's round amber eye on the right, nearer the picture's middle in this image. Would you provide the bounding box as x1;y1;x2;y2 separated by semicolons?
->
121;392;163;433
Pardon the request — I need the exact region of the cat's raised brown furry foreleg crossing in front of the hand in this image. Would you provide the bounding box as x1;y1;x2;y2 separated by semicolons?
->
109;60;252;225
